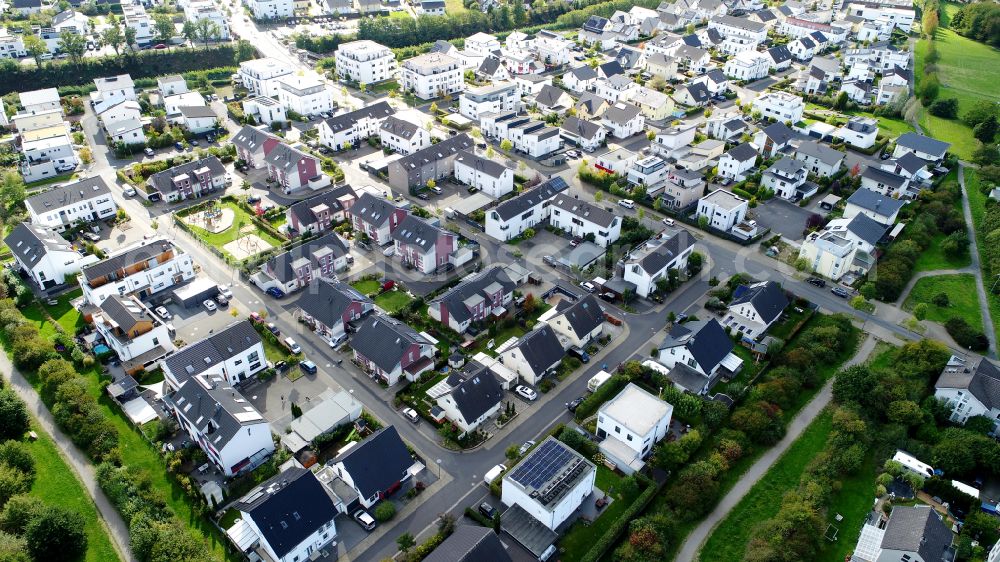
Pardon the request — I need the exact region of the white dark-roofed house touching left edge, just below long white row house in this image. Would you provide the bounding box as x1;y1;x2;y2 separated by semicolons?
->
4;223;98;289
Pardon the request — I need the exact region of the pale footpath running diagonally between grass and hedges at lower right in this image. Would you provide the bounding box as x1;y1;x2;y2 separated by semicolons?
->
675;337;877;562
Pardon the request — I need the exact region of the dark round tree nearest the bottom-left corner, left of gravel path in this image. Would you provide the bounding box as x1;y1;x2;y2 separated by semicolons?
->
24;505;87;561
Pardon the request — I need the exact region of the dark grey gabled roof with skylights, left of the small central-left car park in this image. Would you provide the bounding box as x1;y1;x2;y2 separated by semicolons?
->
163;320;264;384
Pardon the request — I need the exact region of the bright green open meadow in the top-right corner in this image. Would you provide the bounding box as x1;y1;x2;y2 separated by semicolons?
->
914;3;1000;160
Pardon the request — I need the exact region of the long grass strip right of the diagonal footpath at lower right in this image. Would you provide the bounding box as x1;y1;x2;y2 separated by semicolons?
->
699;410;833;562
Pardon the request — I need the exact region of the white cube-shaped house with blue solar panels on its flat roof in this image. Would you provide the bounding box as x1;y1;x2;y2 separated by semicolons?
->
501;436;597;531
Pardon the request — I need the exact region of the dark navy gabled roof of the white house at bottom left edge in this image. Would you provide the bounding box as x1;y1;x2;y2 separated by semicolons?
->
233;466;338;558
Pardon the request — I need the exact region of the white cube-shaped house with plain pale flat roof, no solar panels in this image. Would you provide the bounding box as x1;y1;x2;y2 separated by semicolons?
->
597;383;674;474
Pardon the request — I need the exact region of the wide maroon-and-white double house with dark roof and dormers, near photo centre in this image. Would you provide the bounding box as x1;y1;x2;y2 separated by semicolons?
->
427;267;516;334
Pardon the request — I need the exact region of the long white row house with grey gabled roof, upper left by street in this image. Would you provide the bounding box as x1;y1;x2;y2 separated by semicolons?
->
24;176;118;231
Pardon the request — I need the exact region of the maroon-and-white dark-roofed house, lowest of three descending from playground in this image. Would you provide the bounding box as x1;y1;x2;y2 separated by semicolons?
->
350;314;436;386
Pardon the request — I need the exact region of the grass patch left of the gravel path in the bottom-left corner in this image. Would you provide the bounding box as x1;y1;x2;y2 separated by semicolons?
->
25;421;120;562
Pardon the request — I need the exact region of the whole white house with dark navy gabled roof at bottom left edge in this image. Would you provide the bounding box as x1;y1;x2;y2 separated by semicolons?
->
227;466;340;562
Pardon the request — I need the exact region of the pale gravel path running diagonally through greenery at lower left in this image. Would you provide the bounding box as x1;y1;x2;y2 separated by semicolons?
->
0;352;135;562
